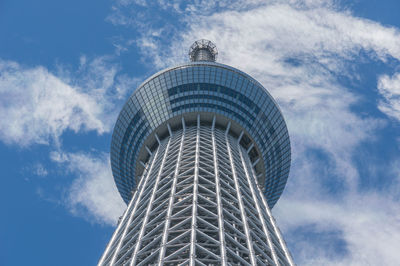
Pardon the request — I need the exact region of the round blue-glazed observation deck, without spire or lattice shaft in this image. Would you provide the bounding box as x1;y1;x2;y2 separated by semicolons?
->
111;61;291;208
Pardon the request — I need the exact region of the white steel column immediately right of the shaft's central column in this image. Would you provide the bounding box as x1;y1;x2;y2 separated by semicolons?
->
211;116;227;266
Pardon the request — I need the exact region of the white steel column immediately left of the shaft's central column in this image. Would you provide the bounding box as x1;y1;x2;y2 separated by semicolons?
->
158;118;186;266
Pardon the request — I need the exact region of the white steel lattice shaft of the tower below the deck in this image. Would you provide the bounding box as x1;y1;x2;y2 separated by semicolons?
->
99;115;294;266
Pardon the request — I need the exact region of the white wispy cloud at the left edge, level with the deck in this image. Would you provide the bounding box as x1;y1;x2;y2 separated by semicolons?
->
0;57;129;146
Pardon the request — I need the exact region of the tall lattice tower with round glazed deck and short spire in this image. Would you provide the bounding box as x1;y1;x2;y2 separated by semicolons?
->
99;40;294;266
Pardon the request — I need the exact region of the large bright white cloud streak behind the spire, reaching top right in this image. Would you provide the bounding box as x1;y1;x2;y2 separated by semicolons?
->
132;1;400;69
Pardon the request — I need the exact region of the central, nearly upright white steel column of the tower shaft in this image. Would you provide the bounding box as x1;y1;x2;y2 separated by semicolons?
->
189;115;200;266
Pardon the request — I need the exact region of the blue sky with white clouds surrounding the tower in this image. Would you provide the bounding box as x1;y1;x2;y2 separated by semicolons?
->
0;0;400;265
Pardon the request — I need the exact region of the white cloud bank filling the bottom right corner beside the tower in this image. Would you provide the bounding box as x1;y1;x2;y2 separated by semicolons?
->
278;191;400;265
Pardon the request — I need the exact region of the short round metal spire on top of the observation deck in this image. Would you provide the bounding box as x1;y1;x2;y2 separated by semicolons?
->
189;39;218;62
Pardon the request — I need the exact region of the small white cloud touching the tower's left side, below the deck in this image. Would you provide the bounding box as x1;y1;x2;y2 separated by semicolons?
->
51;152;126;225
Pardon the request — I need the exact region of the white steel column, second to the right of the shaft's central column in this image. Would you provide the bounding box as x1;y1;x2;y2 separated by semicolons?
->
225;122;257;265
